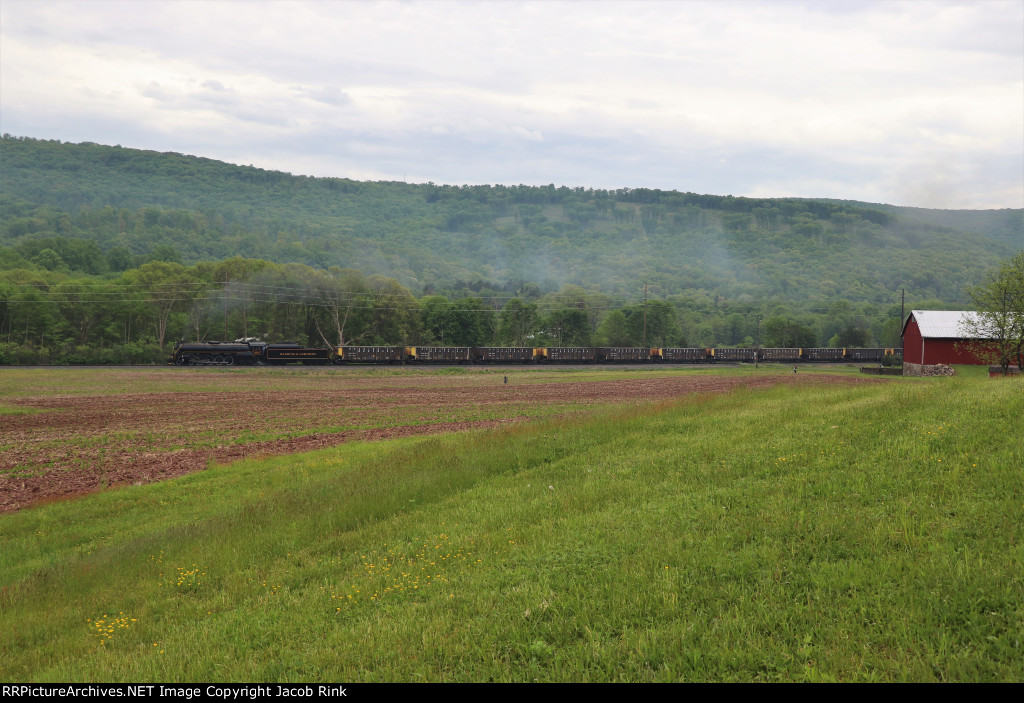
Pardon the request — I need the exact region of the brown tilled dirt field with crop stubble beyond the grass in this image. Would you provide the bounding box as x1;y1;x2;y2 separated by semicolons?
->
0;374;879;513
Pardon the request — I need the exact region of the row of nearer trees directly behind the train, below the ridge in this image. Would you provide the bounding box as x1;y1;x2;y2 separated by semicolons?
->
0;255;913;364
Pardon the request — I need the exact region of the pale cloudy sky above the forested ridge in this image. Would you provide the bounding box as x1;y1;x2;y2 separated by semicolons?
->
0;0;1024;208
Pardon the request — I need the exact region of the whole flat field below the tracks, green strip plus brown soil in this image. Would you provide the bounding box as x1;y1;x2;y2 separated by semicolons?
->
0;367;815;513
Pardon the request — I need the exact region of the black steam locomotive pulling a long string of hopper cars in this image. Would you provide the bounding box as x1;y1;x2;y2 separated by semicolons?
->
169;340;903;366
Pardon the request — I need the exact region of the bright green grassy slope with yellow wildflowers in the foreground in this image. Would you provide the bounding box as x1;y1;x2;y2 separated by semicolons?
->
0;370;1024;682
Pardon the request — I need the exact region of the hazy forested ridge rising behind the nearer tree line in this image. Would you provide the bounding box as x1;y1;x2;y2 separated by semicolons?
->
0;135;1024;302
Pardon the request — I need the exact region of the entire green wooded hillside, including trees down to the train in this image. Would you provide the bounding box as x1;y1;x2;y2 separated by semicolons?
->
0;136;1024;364
